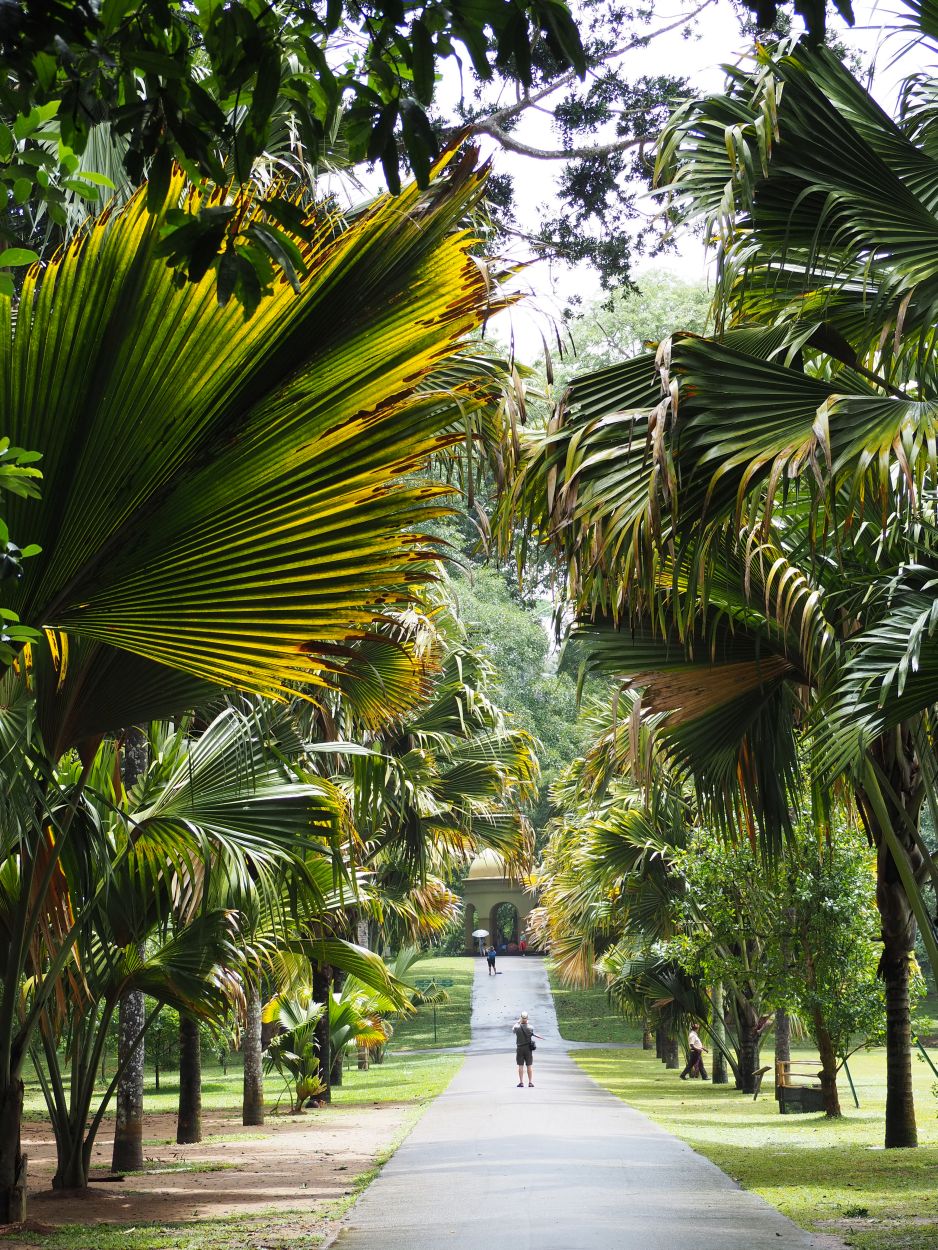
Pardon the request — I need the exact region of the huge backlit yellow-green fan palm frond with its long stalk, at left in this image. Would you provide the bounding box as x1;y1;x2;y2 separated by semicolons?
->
0;148;517;1219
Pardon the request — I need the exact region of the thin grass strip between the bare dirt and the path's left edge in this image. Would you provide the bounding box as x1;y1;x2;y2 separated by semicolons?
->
0;1054;464;1250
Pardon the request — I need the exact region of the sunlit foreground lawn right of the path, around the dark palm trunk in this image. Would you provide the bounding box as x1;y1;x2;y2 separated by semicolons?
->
573;1050;938;1250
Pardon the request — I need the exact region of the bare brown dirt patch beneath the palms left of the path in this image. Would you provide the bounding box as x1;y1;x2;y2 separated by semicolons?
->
0;1103;414;1250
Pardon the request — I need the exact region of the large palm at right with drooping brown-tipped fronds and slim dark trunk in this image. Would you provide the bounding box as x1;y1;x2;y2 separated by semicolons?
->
522;29;938;1146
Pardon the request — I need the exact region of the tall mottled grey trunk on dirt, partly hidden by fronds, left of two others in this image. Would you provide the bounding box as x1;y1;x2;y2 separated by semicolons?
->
111;729;148;1171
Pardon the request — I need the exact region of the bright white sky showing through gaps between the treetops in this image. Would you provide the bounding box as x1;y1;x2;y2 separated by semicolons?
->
493;0;938;364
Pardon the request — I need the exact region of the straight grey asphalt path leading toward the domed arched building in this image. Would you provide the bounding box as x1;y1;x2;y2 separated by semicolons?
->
335;958;839;1250
